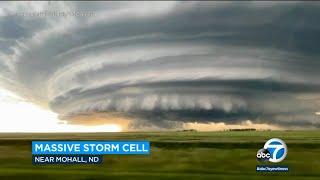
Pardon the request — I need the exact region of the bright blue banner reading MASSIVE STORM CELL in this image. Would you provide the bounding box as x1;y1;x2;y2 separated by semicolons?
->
32;141;150;155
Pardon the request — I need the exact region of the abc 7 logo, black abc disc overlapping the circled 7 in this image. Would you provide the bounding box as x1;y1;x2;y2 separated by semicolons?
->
257;138;287;163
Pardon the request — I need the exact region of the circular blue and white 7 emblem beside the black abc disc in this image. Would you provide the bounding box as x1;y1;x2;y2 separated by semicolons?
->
263;138;288;163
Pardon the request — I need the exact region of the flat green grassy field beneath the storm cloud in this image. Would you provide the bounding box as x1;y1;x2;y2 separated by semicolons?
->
0;131;320;180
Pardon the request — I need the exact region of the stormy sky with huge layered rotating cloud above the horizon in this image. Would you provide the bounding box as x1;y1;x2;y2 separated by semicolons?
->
0;1;320;132
